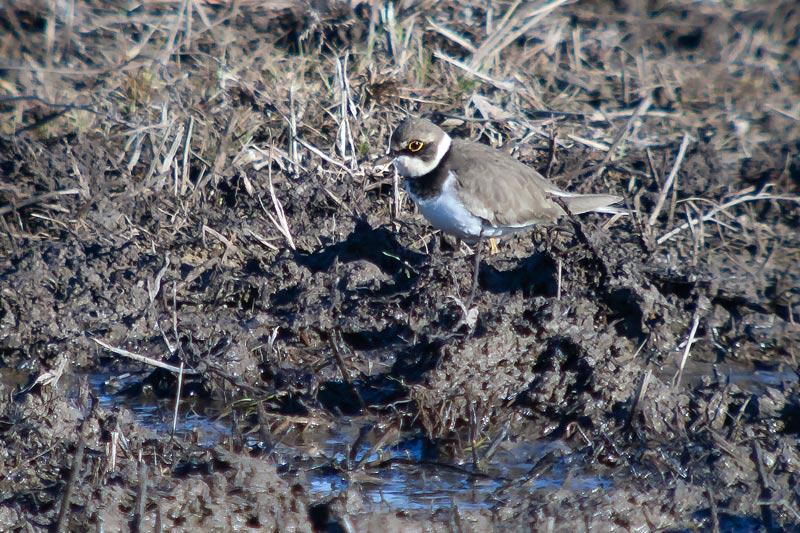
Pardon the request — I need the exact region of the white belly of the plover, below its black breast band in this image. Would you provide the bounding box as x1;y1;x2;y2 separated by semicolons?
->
406;174;524;243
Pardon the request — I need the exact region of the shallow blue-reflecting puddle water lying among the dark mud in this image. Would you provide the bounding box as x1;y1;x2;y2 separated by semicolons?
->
84;363;797;516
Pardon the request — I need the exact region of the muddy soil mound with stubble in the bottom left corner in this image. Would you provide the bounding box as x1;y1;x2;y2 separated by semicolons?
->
0;384;311;531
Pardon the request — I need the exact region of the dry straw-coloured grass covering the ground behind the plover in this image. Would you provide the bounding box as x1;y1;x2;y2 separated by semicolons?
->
0;1;800;364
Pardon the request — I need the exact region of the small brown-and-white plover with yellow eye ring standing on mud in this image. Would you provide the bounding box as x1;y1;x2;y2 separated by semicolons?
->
389;118;627;300
